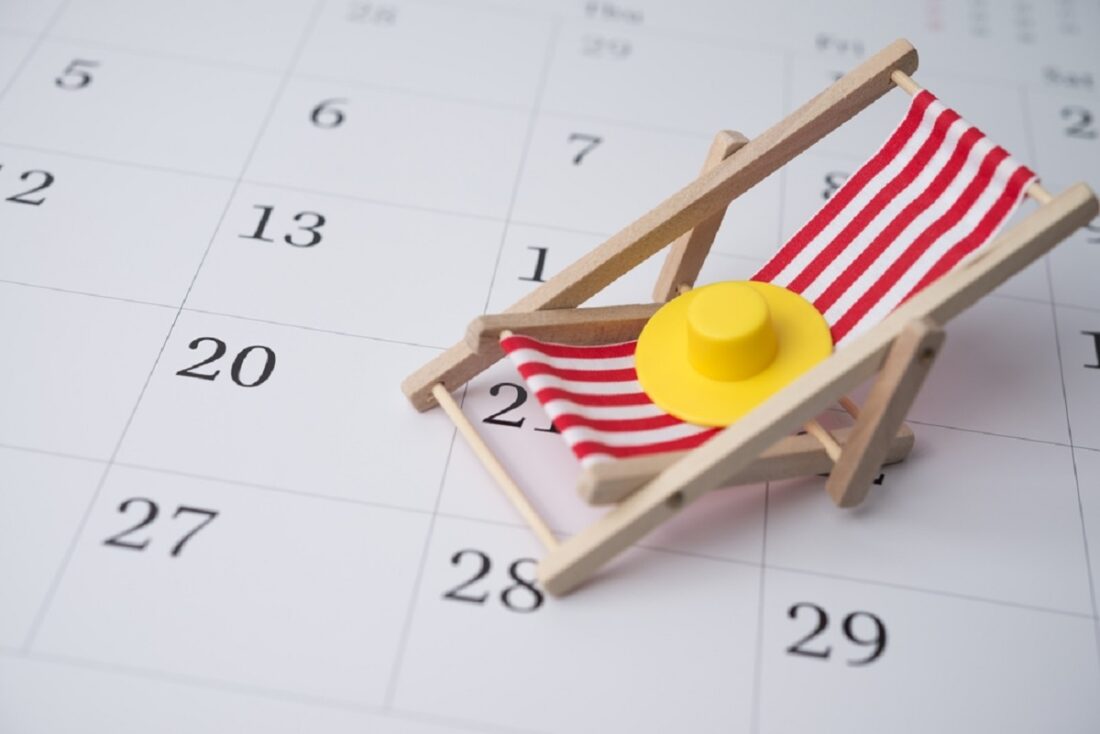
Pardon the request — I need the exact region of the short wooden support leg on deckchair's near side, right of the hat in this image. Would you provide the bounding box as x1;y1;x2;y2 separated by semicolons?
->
825;318;944;507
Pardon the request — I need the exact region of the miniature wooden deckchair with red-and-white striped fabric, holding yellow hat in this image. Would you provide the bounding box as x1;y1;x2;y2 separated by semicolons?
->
403;41;1098;594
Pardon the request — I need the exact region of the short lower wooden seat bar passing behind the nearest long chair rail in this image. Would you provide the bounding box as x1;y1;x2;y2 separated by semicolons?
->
576;425;914;505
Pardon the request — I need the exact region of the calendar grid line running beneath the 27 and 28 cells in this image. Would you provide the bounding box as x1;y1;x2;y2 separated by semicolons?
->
0;647;545;734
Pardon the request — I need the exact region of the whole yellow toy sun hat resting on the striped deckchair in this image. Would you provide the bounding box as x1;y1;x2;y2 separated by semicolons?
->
635;281;833;426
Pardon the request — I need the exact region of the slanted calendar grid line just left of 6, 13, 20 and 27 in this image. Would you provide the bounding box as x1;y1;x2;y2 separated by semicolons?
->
15;0;323;651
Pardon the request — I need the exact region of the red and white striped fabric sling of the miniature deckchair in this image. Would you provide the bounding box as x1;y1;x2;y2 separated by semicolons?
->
501;91;1035;464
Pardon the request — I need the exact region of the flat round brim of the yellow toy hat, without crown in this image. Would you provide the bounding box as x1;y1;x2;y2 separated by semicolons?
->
635;281;833;426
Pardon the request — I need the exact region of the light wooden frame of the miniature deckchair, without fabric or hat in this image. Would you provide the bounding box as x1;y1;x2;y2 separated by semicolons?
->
403;40;1098;594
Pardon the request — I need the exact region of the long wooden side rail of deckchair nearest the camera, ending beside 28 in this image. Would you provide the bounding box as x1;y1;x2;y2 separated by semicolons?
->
539;183;1098;594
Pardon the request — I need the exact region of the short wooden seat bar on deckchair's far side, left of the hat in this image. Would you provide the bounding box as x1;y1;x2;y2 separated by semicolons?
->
466;304;663;354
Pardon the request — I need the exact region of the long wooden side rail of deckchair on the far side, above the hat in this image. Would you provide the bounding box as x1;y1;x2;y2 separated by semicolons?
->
402;40;917;410
